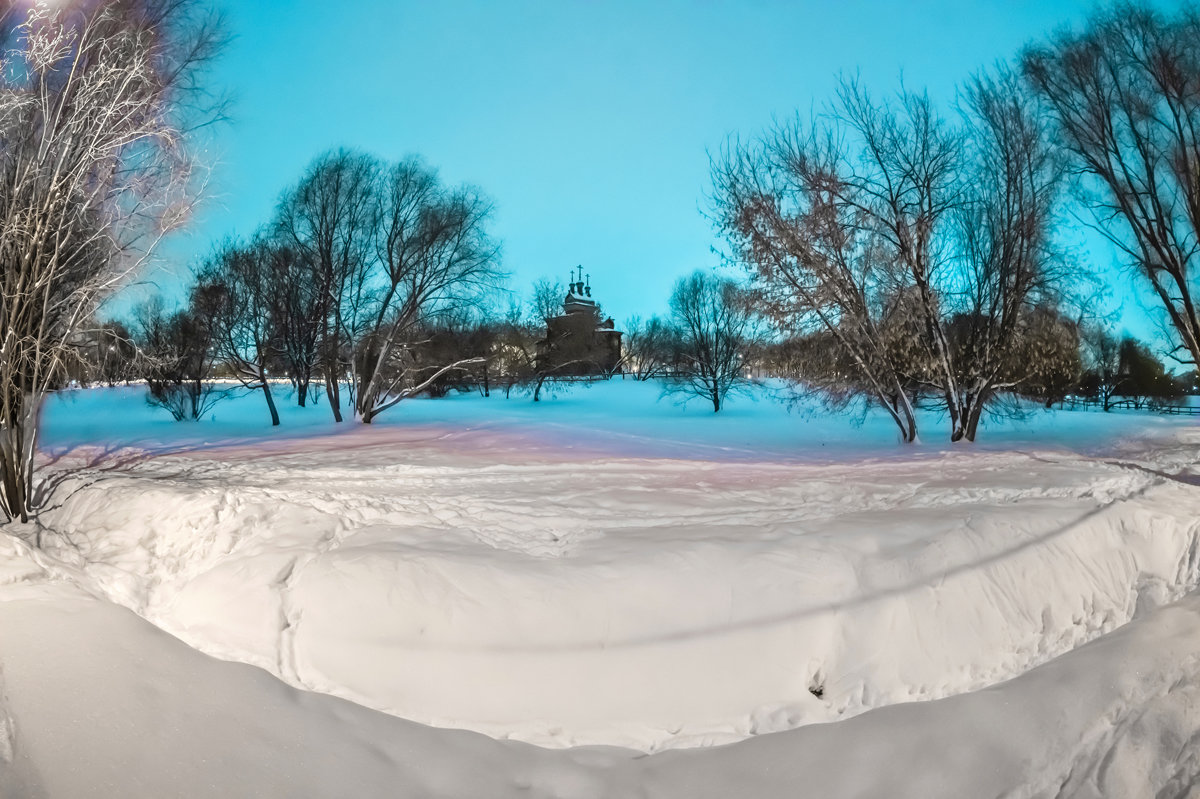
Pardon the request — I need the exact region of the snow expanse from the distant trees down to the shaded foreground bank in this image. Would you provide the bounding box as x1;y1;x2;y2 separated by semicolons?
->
30;384;1200;751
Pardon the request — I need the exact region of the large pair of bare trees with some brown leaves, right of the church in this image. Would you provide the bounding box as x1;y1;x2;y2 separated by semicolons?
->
713;72;1060;441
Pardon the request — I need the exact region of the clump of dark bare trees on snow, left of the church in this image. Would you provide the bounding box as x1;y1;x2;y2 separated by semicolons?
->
114;150;503;425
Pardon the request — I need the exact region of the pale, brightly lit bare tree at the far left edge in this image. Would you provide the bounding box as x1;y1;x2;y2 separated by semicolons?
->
0;0;221;521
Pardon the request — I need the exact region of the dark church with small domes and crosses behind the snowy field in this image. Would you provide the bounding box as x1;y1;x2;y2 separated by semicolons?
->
538;266;622;377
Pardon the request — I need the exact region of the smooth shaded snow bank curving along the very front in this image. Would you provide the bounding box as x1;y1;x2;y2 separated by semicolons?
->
0;536;1200;799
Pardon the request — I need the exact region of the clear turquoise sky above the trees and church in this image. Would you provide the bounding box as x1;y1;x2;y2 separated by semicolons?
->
129;0;1171;335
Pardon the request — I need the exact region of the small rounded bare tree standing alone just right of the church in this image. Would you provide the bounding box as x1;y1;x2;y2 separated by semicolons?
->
671;271;754;413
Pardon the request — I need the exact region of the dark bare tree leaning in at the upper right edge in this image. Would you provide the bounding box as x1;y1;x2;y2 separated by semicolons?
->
1022;2;1200;365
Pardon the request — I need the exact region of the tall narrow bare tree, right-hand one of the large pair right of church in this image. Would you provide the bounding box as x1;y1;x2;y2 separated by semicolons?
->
934;71;1063;441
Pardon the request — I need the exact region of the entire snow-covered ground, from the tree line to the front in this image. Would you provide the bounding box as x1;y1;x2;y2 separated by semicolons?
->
0;382;1200;798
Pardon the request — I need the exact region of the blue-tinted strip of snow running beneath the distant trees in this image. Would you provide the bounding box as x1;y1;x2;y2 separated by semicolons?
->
43;380;1194;463
